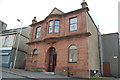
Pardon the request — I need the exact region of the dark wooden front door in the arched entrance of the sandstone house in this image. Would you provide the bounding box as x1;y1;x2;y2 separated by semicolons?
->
48;47;57;72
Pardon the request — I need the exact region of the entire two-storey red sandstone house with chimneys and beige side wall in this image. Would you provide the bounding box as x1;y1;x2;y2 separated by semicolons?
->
25;1;100;77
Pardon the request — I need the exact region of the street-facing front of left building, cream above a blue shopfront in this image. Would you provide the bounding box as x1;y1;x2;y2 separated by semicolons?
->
0;34;15;68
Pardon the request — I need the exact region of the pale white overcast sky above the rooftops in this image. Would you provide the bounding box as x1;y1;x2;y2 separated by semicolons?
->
0;0;119;34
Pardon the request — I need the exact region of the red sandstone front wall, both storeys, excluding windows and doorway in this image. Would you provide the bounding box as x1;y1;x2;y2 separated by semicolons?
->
26;7;89;77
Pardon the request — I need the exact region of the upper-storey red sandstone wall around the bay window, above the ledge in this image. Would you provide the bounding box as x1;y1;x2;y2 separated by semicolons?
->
31;11;87;41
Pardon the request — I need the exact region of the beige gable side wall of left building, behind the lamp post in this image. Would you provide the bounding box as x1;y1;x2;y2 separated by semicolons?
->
13;27;31;68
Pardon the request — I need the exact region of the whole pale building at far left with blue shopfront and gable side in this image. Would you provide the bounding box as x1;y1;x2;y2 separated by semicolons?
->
0;27;30;68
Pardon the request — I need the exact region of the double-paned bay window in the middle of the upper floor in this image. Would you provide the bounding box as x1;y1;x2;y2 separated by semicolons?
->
48;20;60;33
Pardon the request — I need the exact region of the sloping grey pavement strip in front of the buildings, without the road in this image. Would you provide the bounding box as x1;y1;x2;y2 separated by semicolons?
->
2;68;120;80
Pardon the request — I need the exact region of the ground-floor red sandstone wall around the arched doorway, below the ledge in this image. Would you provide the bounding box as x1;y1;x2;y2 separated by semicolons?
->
27;36;88;76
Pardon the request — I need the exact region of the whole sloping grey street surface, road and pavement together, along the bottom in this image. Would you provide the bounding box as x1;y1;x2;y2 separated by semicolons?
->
0;68;119;80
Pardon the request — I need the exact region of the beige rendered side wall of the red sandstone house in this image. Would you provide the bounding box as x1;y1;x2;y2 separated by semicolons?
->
86;13;100;70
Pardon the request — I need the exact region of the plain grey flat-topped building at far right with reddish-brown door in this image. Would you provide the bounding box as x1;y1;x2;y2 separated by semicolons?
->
100;33;120;77
